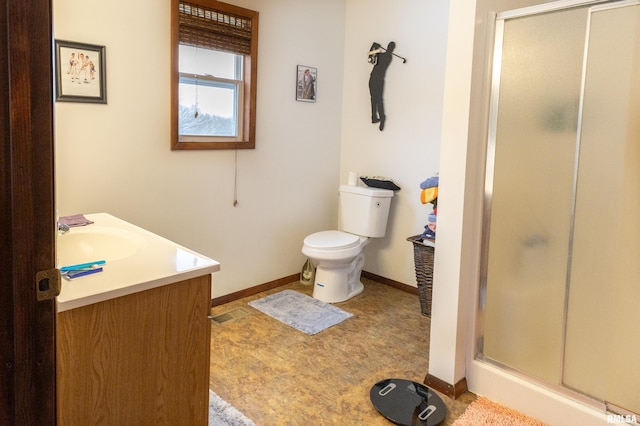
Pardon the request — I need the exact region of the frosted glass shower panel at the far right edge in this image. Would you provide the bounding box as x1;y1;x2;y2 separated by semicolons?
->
564;5;640;413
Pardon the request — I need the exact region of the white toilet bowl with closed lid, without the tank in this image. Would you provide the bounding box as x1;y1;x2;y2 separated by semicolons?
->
302;231;369;303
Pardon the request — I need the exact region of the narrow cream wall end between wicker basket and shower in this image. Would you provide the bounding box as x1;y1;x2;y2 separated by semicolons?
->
422;0;477;402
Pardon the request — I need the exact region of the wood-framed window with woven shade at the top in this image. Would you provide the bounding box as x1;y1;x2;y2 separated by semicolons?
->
171;0;258;150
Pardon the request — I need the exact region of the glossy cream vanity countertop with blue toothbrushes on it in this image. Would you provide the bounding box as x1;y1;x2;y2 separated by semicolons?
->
57;213;220;312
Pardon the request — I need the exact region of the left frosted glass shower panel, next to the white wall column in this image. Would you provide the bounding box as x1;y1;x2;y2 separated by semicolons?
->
483;8;587;383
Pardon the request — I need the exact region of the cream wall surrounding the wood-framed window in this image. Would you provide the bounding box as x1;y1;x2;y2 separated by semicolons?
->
53;0;348;297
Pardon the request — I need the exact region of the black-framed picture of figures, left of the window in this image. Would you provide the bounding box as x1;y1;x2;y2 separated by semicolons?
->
55;40;107;104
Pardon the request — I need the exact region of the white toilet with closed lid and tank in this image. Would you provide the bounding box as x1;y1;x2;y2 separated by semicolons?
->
302;185;393;303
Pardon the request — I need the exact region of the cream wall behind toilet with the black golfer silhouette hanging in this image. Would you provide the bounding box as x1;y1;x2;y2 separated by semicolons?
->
339;0;448;286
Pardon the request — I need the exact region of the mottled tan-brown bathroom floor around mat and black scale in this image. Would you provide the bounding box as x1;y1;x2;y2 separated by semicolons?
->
210;279;475;426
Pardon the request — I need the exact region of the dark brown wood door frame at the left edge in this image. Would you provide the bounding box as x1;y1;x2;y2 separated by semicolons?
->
0;0;56;425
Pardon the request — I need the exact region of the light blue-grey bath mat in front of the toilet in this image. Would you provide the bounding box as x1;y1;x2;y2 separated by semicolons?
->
249;290;353;334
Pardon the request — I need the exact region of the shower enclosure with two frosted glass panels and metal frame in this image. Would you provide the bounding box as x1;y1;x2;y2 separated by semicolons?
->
476;1;640;418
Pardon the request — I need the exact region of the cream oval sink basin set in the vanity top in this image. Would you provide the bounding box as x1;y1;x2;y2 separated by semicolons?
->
57;225;145;266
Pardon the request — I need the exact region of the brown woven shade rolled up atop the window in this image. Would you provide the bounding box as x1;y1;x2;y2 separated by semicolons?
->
178;1;251;55
